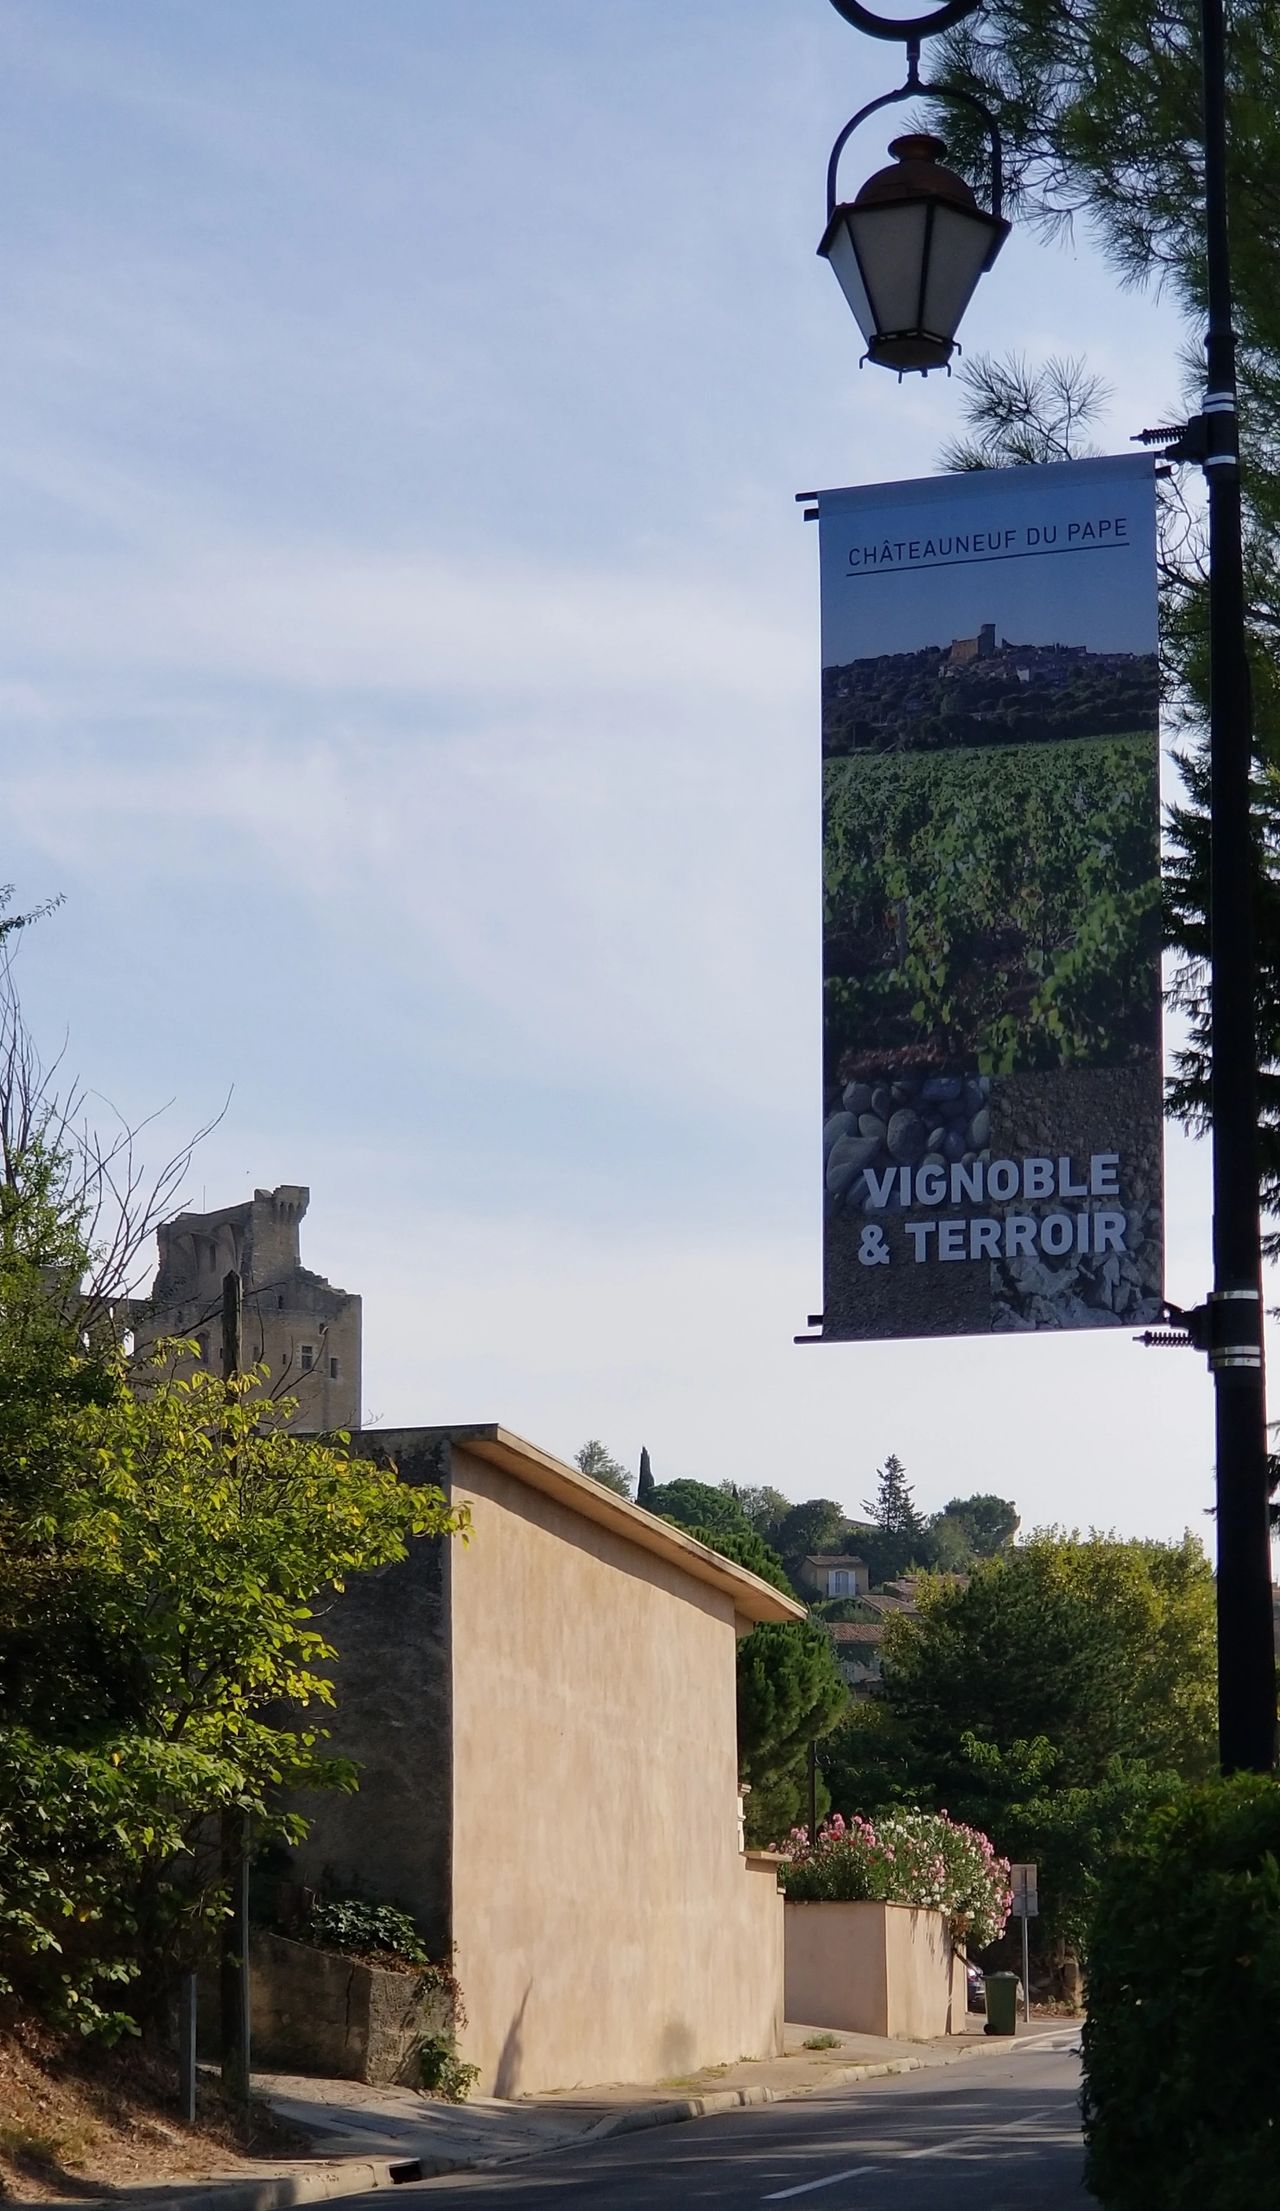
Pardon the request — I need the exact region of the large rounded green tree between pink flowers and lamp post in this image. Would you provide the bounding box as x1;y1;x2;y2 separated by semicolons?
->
822;1532;1216;1961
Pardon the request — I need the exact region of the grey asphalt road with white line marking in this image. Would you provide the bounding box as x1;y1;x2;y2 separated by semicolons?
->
396;2045;1097;2211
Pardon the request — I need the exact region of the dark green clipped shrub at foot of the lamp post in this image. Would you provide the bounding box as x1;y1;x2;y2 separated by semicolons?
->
1083;1773;1280;2211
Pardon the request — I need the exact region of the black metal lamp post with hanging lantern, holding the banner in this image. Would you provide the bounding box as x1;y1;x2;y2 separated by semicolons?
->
820;0;1276;1773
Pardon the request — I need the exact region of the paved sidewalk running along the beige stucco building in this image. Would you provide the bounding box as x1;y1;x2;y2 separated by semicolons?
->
35;2014;1079;2211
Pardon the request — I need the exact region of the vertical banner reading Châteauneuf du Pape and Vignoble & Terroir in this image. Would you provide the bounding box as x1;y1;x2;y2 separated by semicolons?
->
818;455;1163;1340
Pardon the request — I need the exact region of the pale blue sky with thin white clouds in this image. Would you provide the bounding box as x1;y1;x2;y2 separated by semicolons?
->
0;0;1264;1534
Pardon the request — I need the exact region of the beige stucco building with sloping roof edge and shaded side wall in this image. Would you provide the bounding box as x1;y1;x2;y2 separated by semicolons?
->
296;1426;802;2096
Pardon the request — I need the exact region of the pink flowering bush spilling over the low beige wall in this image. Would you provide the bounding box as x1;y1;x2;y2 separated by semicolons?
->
780;1811;1013;1950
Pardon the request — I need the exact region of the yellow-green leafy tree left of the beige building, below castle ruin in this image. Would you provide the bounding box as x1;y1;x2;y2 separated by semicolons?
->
0;1369;464;2025
